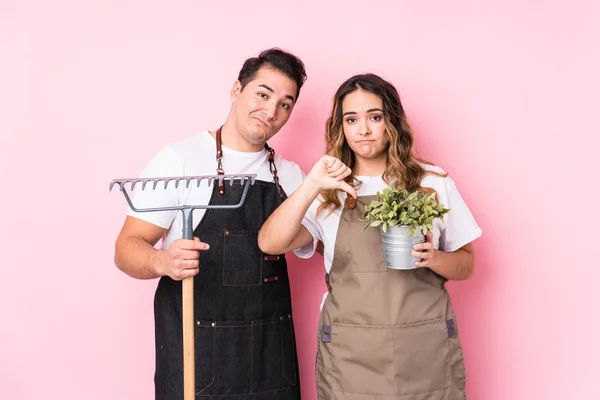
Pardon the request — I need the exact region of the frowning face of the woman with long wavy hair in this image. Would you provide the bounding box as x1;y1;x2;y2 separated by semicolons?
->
342;89;389;170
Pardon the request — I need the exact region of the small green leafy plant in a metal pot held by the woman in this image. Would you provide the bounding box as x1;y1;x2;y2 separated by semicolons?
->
363;184;450;269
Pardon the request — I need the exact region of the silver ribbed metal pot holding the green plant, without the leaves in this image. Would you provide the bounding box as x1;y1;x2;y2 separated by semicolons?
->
380;225;425;269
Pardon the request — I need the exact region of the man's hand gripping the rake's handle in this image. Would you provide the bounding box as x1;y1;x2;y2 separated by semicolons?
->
156;237;210;281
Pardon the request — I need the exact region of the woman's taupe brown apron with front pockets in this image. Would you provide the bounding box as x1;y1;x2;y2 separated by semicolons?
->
317;196;465;400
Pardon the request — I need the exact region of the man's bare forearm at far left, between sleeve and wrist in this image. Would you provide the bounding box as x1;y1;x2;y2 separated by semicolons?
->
115;236;162;279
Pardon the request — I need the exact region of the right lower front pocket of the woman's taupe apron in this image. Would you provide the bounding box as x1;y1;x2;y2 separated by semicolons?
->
394;318;451;395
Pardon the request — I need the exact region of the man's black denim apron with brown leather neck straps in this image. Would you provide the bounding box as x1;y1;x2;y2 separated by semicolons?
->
154;132;300;400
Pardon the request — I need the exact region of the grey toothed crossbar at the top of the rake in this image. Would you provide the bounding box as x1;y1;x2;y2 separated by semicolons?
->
108;174;256;191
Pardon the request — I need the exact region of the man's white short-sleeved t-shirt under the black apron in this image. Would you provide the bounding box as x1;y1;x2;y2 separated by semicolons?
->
127;131;304;249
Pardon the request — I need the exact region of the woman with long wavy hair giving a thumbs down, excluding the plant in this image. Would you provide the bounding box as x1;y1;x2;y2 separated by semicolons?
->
259;74;481;400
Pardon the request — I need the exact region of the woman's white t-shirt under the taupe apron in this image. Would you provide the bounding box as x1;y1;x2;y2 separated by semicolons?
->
294;165;481;307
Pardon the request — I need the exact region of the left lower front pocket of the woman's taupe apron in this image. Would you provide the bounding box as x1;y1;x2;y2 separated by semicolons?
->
330;323;395;395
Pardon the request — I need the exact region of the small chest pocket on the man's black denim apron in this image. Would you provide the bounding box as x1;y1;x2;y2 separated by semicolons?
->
221;229;263;286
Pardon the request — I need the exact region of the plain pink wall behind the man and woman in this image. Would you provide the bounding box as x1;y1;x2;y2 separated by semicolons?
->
0;0;600;400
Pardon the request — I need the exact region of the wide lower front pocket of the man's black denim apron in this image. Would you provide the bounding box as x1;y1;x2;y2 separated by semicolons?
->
196;314;298;397
